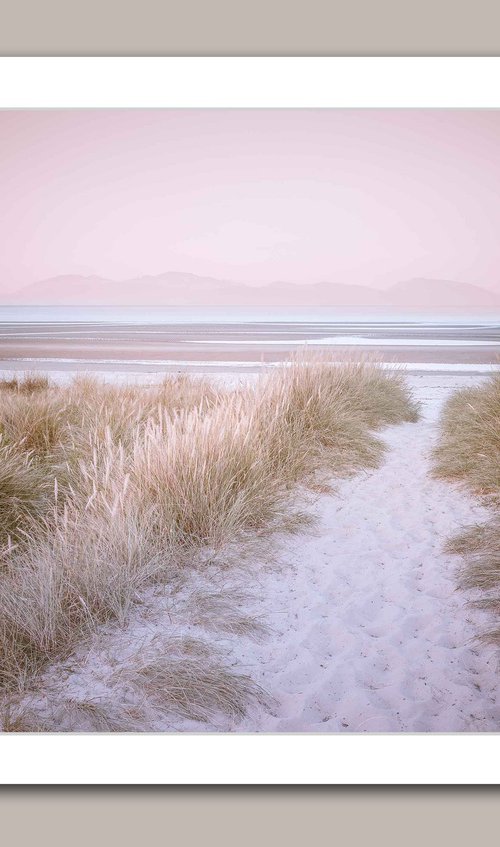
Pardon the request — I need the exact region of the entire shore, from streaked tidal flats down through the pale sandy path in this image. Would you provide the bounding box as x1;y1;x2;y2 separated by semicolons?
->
0;308;500;732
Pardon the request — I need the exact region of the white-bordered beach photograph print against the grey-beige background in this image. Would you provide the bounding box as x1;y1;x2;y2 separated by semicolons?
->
0;57;500;784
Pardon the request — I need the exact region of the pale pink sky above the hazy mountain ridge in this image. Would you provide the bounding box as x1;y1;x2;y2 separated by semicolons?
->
0;109;500;293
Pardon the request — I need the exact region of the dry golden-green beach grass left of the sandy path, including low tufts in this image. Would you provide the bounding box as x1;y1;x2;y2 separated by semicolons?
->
0;354;418;728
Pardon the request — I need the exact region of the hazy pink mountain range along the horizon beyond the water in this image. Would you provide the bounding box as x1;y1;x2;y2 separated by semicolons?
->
4;272;500;308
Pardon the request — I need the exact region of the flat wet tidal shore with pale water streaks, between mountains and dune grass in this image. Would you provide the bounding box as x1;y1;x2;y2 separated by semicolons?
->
0;321;500;370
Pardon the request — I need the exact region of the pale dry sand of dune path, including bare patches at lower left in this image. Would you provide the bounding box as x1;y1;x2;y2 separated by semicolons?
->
4;375;500;732
